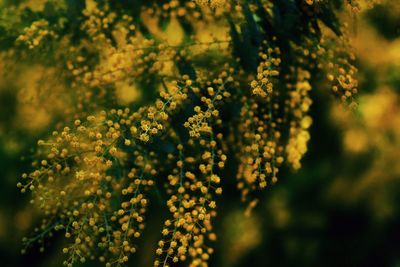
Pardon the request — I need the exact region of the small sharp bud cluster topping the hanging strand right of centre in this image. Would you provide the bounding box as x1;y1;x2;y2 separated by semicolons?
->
250;48;281;98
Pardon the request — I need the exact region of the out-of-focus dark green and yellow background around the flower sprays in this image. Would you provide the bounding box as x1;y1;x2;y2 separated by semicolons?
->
0;1;400;267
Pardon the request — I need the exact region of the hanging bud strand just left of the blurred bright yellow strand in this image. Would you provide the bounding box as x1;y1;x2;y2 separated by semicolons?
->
237;44;284;205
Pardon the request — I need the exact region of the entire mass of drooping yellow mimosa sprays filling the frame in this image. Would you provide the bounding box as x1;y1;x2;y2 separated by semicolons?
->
11;0;357;266
